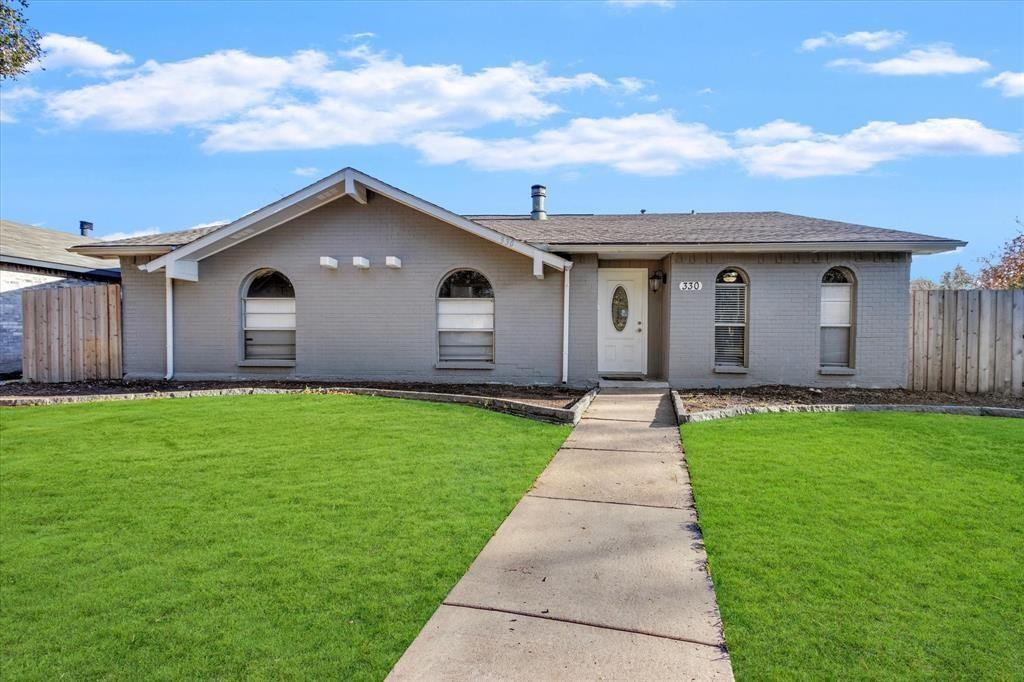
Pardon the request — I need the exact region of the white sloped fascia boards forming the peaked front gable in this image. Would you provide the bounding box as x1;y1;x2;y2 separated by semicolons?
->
143;168;569;272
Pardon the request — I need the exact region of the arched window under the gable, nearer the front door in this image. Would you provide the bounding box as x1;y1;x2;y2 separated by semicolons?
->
437;270;495;363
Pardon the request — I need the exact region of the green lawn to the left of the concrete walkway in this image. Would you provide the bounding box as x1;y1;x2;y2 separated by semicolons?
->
0;395;569;680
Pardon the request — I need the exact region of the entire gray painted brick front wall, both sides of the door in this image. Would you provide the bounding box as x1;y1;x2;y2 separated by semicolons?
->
122;197;909;387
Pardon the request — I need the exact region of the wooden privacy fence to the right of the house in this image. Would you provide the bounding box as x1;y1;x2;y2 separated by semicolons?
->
907;290;1024;395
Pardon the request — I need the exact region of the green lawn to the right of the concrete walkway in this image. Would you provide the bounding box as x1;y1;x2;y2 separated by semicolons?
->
682;414;1024;680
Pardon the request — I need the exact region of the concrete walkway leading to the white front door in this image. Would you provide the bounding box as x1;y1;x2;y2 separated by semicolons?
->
389;389;732;680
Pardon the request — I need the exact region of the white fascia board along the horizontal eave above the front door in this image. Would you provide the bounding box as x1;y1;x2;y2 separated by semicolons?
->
550;241;967;254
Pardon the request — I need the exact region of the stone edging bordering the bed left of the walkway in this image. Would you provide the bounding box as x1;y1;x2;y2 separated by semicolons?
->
0;386;598;424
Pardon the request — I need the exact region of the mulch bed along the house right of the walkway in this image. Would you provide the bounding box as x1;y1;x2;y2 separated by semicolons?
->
679;386;1024;412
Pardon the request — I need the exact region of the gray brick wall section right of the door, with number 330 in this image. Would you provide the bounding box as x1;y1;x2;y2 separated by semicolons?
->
669;253;910;387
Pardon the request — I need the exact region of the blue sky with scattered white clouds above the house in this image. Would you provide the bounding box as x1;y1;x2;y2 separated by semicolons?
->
0;1;1024;278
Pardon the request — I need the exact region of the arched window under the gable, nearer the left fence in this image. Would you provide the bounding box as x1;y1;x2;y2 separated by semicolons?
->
242;270;295;360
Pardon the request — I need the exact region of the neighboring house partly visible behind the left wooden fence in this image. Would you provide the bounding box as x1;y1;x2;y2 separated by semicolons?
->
0;220;121;375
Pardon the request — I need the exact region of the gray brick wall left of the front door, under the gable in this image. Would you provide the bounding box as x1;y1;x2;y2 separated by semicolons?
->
125;196;596;383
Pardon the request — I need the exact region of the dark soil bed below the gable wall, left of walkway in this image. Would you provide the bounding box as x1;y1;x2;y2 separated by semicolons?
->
0;380;587;408
